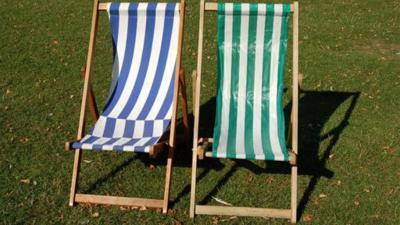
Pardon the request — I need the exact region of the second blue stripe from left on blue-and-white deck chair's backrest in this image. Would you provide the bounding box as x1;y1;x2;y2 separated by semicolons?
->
103;3;138;116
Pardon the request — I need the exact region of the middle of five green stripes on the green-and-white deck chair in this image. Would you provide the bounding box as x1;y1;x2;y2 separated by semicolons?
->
244;4;258;159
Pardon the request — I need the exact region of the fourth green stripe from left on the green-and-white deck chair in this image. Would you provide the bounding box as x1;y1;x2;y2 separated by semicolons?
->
261;4;274;159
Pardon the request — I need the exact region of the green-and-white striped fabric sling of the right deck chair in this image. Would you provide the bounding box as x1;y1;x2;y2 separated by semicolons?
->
212;3;290;161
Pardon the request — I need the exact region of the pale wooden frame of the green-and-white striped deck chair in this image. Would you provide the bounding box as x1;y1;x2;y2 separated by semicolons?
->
190;0;299;223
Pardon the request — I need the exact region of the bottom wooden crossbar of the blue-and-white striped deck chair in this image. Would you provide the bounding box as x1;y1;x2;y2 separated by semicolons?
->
75;194;163;208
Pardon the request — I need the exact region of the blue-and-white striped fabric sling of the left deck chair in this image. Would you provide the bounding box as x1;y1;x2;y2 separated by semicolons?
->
72;3;179;152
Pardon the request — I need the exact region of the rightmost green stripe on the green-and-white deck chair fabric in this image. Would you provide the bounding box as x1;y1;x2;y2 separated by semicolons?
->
277;4;290;160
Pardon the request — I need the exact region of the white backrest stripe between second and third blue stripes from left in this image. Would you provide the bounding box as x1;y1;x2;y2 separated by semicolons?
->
108;3;147;118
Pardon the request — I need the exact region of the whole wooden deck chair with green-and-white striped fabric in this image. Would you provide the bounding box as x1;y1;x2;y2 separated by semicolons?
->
190;0;299;223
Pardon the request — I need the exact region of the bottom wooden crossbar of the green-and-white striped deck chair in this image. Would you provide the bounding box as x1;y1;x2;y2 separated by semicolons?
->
195;205;291;219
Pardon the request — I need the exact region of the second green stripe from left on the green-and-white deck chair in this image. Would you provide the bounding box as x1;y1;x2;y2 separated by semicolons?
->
227;3;242;158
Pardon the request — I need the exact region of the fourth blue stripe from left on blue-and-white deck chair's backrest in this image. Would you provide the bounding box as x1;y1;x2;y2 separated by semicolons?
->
138;4;175;120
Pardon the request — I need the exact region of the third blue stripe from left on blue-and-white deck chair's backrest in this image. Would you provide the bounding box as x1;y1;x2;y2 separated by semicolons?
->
118;3;156;118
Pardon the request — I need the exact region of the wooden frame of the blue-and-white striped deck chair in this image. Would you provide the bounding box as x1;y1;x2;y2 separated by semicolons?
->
65;0;189;214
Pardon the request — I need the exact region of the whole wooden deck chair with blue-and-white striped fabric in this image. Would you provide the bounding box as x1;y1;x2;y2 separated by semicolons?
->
66;0;187;213
